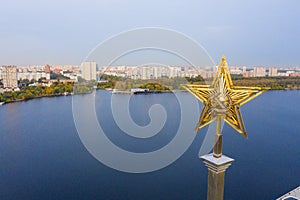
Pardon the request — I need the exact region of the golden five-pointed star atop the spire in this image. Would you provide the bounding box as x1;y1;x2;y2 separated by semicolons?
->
183;56;268;138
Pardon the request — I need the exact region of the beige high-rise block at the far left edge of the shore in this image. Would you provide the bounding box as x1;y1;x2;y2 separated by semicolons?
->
1;66;18;89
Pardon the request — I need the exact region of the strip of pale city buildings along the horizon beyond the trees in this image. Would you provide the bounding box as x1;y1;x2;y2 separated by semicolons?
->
0;62;300;88
